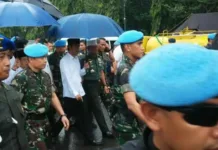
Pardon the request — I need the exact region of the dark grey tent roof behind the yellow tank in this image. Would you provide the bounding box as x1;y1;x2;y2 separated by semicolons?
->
175;12;218;32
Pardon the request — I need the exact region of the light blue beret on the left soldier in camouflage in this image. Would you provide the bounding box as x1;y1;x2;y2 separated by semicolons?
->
24;43;48;58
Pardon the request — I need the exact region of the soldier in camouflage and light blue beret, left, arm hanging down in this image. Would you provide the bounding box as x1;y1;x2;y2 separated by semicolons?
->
12;44;69;150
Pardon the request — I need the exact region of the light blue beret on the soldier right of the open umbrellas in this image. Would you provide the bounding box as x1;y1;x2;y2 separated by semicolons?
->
118;30;144;44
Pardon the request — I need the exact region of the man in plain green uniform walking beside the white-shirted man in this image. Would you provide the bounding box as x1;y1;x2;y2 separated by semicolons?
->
83;40;112;140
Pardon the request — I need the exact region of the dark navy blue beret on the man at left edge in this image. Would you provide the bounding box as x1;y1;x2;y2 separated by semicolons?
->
0;37;16;51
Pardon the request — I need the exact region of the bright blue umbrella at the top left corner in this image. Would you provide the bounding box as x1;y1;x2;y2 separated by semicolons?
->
0;2;58;27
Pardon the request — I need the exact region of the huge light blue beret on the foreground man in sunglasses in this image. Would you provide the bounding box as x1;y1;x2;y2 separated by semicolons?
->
130;44;218;106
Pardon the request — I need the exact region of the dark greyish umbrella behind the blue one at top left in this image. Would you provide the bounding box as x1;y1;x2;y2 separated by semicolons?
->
0;0;63;19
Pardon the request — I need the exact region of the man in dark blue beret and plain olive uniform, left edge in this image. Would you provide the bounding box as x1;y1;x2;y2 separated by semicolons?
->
0;38;28;150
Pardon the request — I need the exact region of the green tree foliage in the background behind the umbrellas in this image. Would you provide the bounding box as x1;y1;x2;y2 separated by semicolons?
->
0;0;218;39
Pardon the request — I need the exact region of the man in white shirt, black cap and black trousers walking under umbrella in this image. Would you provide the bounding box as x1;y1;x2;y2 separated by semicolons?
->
60;39;96;144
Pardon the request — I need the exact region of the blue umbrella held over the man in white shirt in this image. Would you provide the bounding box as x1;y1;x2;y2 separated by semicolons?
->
48;13;123;39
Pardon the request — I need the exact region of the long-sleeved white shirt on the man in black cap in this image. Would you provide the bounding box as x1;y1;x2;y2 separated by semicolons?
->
60;53;86;98
